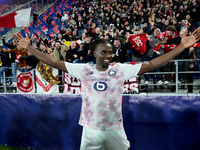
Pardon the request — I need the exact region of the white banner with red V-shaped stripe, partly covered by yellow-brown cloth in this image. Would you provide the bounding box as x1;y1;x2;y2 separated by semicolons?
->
35;68;59;94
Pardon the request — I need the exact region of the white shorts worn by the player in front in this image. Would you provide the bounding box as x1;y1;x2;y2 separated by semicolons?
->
80;127;130;150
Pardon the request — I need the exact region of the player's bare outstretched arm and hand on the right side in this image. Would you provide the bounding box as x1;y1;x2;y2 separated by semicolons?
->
138;27;200;75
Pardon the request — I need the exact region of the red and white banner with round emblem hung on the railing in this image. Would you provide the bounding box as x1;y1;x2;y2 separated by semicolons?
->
17;70;35;93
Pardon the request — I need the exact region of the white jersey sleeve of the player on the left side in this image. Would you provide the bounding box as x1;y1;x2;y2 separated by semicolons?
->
65;62;85;79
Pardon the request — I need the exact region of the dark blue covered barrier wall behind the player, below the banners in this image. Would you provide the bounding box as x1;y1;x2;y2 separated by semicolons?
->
0;94;200;150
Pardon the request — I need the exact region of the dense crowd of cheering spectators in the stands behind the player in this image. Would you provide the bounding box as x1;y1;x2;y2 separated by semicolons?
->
0;0;200;92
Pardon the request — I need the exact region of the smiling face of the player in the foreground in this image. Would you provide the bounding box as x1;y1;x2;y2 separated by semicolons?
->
94;44;113;71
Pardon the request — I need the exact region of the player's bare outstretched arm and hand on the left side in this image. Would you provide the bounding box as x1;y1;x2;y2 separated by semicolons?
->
12;33;68;72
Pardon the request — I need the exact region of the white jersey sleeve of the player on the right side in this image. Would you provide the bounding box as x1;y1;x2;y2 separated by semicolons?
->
119;63;142;80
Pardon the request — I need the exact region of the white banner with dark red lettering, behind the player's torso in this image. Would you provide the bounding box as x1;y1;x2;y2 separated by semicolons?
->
63;72;139;94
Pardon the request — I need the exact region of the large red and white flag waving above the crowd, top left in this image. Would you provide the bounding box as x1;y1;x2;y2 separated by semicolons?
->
0;8;31;28
